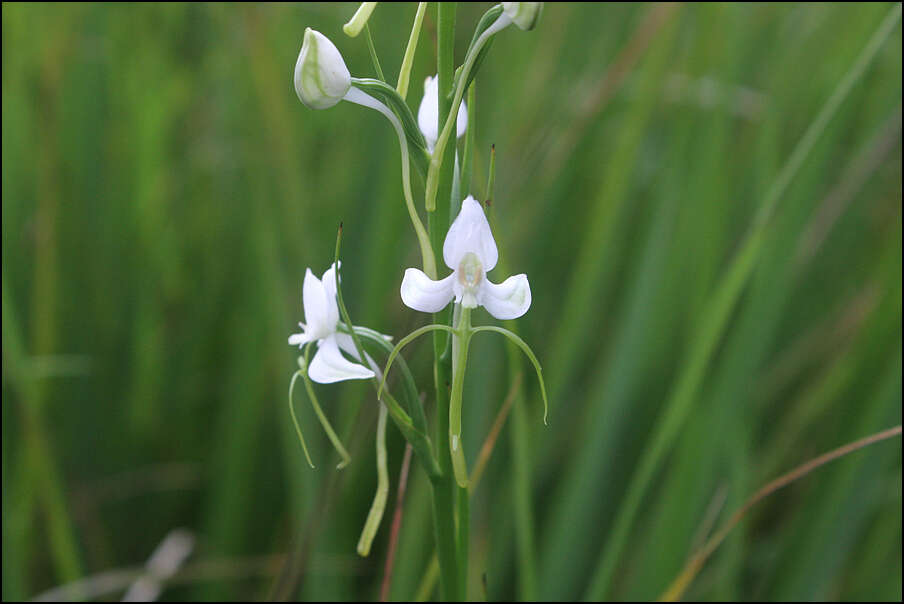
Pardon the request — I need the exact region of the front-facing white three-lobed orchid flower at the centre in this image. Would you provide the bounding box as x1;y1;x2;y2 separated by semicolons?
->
402;195;531;320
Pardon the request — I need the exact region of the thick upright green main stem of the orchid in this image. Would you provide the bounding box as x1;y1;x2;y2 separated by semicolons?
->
427;2;465;601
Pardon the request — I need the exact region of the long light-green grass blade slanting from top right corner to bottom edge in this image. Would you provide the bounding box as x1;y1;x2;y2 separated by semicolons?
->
586;4;901;600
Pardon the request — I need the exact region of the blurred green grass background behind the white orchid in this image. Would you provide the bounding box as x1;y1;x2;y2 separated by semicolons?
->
2;3;902;600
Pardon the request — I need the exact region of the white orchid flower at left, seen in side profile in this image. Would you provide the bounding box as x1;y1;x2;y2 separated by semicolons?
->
289;263;375;384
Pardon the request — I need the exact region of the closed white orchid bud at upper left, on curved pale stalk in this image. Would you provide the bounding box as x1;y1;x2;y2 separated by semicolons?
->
295;27;352;109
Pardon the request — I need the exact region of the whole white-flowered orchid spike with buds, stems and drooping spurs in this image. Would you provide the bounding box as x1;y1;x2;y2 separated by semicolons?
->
289;2;546;595
